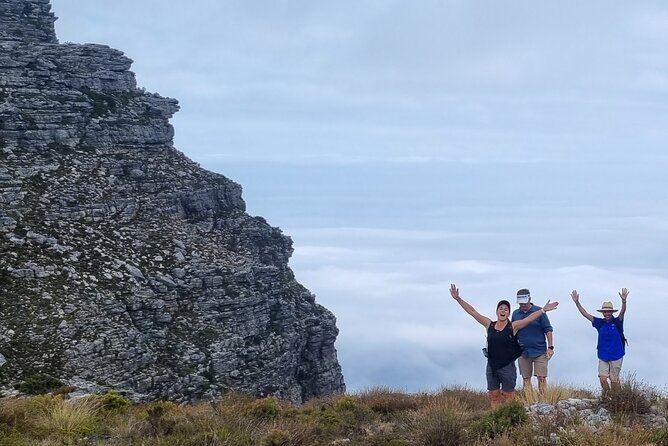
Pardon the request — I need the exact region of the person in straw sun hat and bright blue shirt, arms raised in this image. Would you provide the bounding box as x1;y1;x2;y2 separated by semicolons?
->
571;288;629;394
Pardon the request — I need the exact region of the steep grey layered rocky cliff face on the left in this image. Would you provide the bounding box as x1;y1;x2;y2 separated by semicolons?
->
0;0;344;401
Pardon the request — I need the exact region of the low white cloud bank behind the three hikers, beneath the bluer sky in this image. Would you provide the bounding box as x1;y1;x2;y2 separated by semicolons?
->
292;231;668;391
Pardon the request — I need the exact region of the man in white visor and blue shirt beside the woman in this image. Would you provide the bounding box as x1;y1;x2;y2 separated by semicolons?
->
512;288;554;393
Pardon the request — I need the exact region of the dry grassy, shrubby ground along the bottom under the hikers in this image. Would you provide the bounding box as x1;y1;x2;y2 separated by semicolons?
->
0;378;668;446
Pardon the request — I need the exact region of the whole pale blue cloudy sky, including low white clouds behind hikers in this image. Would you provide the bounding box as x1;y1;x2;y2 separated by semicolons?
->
51;0;668;392
